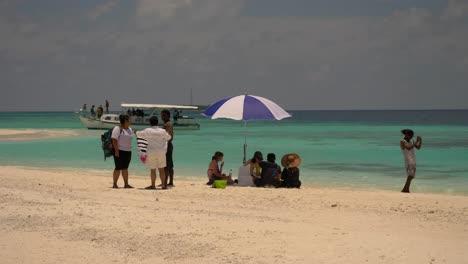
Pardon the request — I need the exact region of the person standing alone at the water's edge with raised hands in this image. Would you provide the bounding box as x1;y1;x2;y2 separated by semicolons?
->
400;129;422;193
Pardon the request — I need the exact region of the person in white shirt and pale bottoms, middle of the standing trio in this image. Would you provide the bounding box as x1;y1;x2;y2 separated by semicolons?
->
136;116;171;189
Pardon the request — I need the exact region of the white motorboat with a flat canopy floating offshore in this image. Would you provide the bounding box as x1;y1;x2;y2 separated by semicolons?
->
78;103;200;130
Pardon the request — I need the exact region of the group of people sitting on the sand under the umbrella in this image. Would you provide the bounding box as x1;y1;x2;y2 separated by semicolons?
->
206;151;301;188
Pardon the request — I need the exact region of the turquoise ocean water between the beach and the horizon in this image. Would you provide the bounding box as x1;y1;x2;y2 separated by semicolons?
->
0;110;468;195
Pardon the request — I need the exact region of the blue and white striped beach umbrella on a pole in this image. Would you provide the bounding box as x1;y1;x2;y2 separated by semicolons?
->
203;94;291;162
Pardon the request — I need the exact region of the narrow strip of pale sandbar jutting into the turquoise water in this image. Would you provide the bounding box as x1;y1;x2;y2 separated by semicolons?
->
0;129;78;140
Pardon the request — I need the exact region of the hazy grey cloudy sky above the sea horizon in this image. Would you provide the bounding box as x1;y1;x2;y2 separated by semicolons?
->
0;0;468;111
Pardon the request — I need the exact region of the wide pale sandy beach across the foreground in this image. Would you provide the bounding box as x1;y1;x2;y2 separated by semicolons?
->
0;167;468;263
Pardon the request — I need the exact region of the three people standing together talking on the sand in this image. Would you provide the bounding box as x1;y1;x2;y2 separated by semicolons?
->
112;110;174;190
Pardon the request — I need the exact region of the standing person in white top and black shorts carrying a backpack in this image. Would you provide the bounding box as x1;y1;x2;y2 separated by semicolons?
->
112;114;133;189
